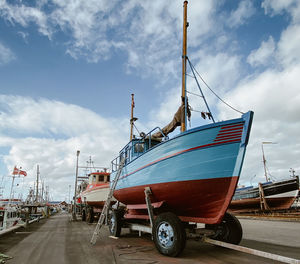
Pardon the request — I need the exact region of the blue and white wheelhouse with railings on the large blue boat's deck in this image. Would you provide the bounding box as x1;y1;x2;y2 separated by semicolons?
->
111;127;169;172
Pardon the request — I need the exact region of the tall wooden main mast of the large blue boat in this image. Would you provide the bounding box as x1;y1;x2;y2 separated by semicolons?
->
181;1;188;132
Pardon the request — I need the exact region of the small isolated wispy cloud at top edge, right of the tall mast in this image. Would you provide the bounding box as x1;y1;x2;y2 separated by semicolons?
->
227;0;255;28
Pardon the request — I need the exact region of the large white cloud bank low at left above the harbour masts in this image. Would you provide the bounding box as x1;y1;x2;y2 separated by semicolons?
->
0;96;129;199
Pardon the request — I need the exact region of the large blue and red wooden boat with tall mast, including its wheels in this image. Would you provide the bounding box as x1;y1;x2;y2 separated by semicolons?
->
110;1;253;256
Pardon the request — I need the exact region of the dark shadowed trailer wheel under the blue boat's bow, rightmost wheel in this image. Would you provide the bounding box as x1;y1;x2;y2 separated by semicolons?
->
205;213;243;245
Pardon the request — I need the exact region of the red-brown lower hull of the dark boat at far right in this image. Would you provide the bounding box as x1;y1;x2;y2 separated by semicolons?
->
229;197;296;212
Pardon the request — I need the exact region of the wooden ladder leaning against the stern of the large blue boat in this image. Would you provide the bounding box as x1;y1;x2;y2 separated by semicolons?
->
91;159;125;245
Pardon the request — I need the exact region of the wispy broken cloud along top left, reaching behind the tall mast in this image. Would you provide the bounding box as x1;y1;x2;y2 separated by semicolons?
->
0;0;220;80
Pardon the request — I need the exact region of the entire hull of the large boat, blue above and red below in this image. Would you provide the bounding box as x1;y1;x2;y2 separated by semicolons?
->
111;112;252;224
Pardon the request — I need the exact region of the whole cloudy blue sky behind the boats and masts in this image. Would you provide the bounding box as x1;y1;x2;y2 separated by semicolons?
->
0;0;300;201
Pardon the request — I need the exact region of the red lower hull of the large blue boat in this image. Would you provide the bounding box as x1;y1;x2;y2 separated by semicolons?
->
114;176;238;224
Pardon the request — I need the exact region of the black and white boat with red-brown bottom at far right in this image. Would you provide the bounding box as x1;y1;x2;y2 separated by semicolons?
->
229;177;299;212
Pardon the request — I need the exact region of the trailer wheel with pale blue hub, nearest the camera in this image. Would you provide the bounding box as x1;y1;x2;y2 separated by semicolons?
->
152;212;186;257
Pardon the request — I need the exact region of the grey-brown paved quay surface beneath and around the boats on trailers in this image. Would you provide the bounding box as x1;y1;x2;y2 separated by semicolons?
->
0;213;300;264
